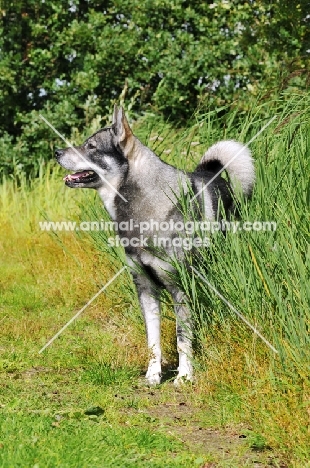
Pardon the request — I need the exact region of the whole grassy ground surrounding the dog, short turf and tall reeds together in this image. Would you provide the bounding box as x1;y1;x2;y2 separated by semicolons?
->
0;95;310;468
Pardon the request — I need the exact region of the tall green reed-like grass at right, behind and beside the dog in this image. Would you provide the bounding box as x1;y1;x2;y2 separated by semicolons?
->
171;95;310;372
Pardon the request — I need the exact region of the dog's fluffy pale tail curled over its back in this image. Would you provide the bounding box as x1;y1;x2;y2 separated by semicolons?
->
196;140;255;196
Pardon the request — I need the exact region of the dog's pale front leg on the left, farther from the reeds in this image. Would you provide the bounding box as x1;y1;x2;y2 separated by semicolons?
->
137;285;161;385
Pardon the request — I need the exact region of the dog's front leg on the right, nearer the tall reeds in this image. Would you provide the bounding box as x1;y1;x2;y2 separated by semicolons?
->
170;289;193;386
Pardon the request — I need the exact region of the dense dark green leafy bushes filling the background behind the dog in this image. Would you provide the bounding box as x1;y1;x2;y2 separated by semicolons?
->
0;0;310;173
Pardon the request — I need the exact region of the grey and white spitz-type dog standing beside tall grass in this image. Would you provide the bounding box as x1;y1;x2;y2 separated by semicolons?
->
55;106;255;385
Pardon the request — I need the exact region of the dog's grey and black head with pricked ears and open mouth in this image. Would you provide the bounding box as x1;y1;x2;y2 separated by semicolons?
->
55;106;134;189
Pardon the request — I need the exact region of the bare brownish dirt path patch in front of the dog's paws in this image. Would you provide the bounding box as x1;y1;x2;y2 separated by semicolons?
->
127;389;288;468
